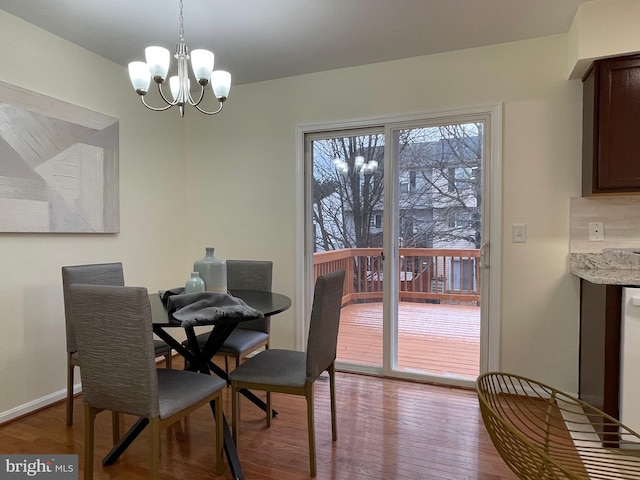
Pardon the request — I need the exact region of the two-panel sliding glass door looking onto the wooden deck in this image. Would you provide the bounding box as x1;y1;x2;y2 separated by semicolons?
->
304;106;497;385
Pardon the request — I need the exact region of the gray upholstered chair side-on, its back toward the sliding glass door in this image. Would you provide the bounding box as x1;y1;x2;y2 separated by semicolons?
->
229;270;345;477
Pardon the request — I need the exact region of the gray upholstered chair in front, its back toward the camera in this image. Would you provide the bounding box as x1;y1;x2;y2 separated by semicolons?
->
69;283;226;480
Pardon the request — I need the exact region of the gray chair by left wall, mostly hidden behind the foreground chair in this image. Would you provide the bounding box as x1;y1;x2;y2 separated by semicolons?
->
62;262;171;426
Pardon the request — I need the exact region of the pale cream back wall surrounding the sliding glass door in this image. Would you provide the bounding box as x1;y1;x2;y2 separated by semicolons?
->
186;35;582;392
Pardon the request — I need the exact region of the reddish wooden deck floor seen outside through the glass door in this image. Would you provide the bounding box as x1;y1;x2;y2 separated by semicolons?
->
338;302;480;380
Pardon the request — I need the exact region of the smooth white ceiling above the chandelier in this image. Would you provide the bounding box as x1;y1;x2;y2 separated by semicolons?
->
0;0;588;85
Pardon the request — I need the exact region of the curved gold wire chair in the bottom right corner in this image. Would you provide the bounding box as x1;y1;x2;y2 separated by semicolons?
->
476;372;640;480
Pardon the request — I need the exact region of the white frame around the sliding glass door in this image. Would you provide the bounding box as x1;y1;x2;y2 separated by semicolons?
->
295;103;503;387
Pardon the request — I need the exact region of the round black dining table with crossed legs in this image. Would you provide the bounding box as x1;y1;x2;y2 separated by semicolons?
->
102;290;291;479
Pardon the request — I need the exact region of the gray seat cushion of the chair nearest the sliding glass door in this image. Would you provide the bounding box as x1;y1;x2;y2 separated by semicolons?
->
229;348;307;387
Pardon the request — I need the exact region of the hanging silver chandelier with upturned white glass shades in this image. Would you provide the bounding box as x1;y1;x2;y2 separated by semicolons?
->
129;0;231;117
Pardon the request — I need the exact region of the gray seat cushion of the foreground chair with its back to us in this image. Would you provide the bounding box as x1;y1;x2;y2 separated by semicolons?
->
158;368;227;418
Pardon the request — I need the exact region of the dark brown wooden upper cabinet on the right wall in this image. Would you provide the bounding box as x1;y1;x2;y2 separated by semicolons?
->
582;55;640;196
